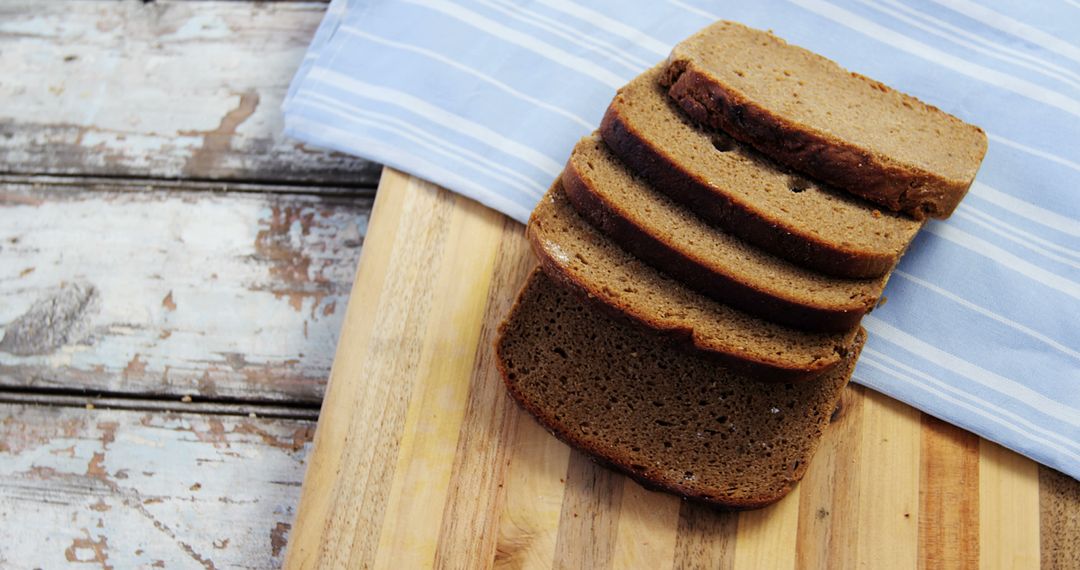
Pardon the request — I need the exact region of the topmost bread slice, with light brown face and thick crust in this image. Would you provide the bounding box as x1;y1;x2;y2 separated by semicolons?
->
662;22;986;219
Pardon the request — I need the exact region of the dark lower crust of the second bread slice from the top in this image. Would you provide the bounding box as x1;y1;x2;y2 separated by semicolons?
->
599;86;920;279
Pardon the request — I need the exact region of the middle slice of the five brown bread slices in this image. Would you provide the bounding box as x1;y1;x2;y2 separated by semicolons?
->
562;135;888;331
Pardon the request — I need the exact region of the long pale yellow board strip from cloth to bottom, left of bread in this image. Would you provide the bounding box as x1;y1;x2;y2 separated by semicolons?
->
375;189;504;569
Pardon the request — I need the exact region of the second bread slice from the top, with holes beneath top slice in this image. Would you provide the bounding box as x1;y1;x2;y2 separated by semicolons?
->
600;67;921;279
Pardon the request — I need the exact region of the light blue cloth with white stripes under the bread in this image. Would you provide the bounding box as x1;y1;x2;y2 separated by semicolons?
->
284;0;1080;478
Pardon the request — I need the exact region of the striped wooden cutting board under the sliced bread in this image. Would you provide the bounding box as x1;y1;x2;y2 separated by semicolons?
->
286;169;1080;569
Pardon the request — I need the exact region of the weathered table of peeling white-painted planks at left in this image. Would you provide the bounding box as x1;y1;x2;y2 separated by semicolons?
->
0;0;378;569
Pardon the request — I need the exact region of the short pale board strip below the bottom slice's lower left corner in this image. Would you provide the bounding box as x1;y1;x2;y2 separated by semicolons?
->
495;412;570;570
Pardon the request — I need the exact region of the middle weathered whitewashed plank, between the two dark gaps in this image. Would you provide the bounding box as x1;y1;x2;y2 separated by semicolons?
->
0;180;372;405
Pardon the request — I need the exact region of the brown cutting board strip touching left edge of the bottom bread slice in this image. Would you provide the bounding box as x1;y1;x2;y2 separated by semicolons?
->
435;217;536;568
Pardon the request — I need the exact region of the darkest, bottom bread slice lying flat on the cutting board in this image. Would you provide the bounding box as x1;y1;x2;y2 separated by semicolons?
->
496;271;865;510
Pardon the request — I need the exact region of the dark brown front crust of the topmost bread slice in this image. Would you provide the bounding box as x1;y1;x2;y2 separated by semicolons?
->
661;54;986;220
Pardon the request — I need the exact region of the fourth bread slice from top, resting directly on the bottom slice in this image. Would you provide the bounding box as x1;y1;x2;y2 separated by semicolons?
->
527;180;856;381
